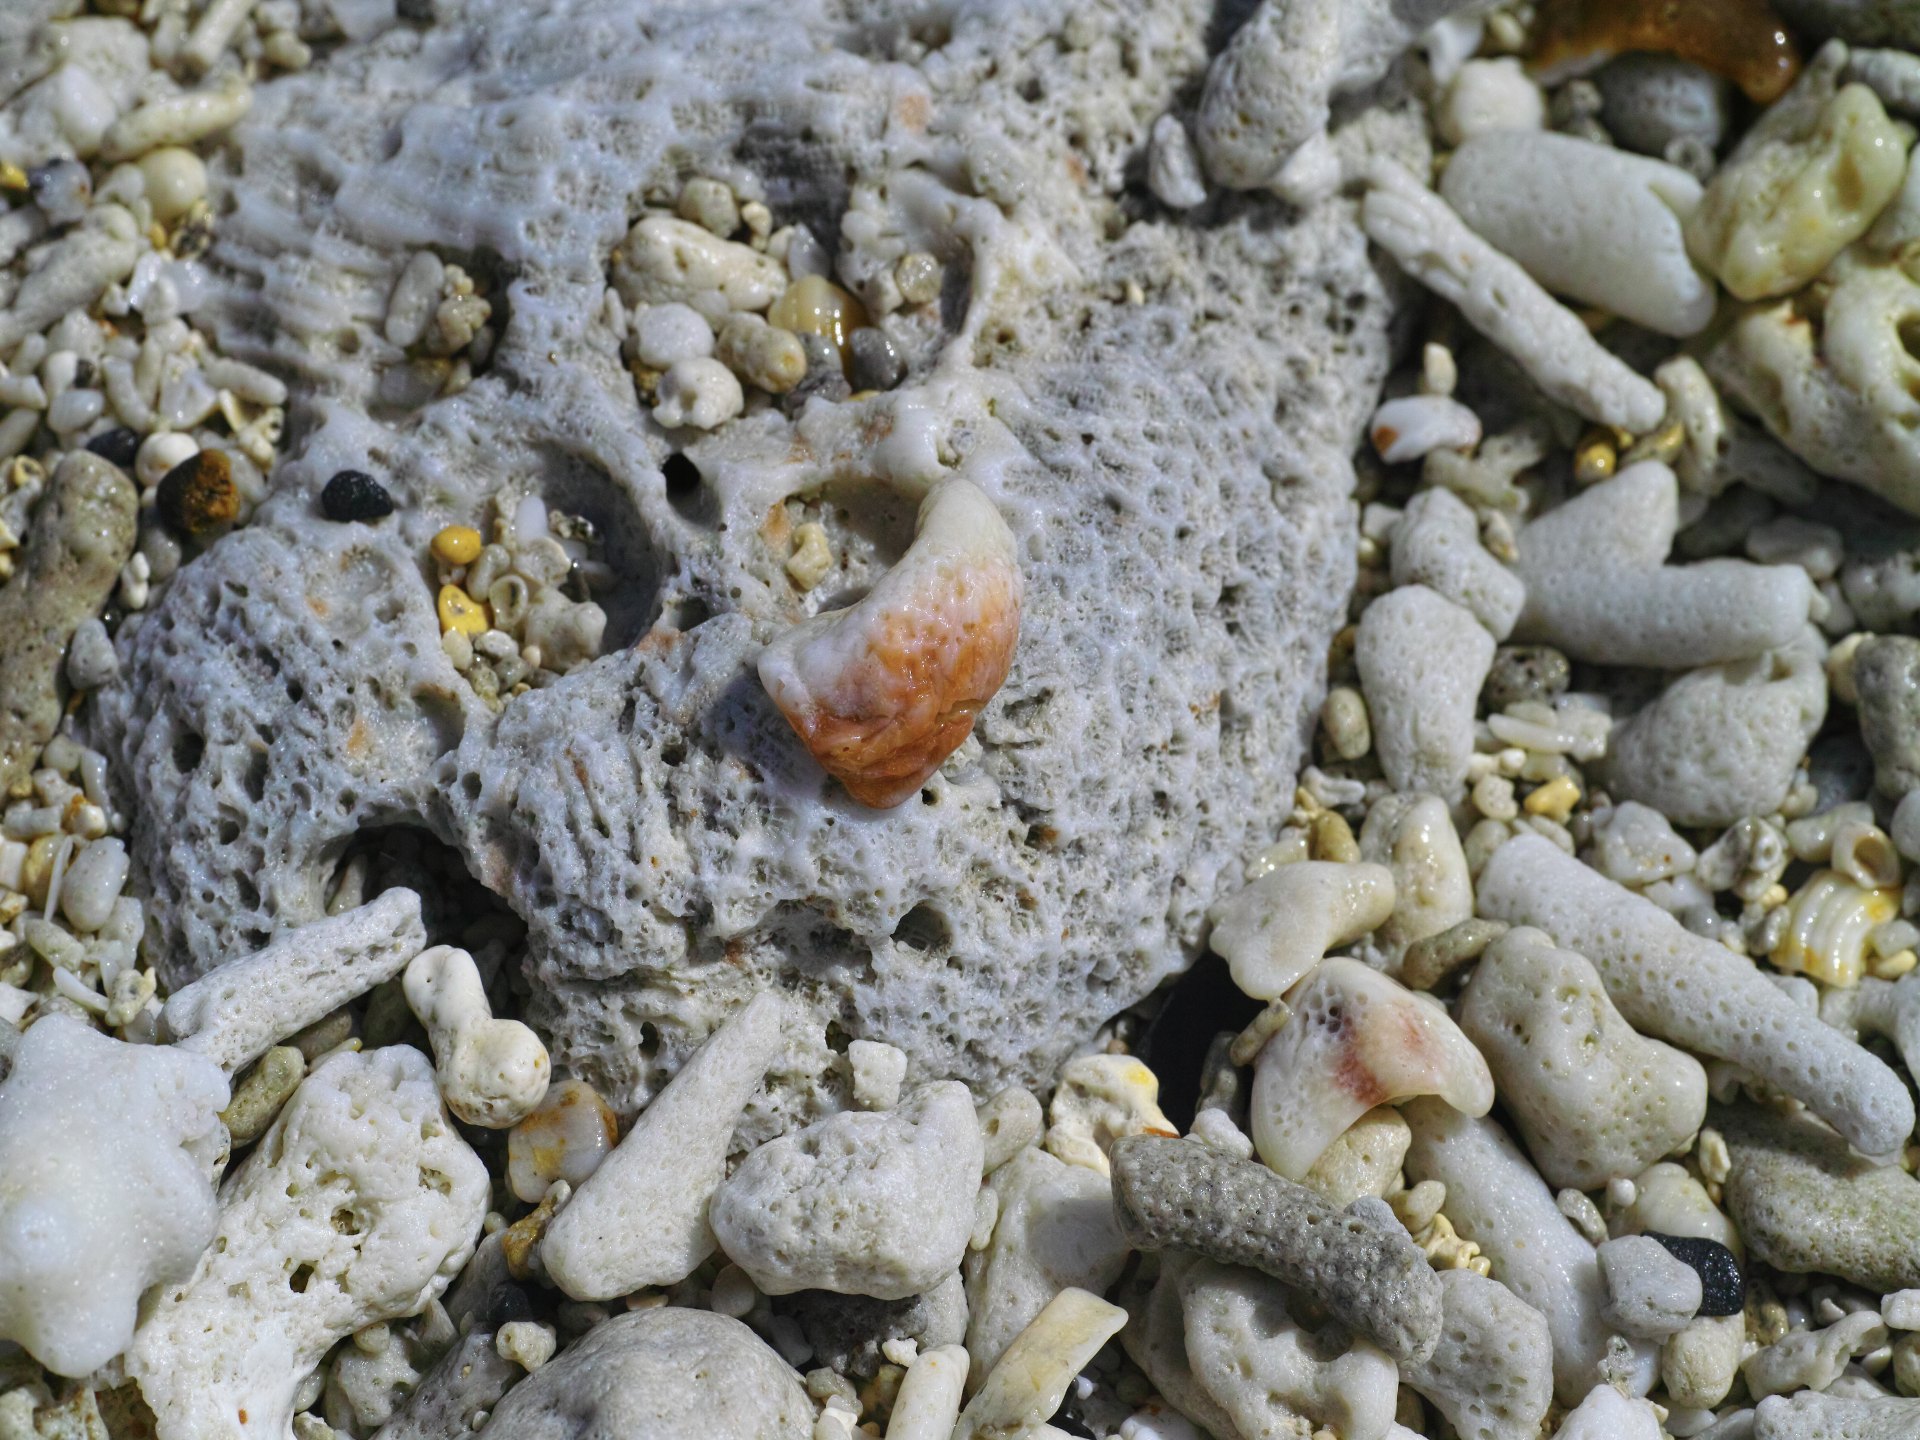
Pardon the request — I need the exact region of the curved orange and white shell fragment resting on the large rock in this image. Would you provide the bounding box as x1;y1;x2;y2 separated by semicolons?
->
760;478;1021;808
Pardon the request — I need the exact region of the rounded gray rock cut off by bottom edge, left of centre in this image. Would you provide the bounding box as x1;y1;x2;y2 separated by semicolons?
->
486;1306;814;1440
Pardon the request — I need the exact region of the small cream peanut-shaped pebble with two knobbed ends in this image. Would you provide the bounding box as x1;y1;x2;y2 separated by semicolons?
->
405;945;553;1131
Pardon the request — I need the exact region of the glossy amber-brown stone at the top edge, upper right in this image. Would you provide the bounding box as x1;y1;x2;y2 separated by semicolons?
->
1532;0;1801;106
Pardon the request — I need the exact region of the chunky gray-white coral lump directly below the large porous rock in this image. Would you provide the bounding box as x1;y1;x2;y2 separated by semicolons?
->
708;1081;983;1300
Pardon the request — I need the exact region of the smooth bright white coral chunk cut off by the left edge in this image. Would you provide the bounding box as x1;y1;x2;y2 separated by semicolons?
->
0;1014;227;1375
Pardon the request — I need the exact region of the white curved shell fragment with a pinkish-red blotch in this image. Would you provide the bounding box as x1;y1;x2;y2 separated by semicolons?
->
1252;958;1494;1181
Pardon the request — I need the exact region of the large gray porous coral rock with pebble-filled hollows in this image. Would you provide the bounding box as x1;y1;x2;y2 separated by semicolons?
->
98;0;1425;1137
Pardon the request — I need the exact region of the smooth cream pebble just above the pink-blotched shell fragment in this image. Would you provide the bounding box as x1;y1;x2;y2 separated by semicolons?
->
1208;860;1396;1000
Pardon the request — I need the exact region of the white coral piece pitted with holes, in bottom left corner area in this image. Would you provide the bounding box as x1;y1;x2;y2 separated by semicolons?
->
127;1046;488;1440
